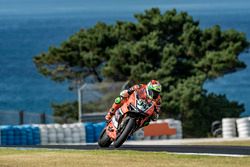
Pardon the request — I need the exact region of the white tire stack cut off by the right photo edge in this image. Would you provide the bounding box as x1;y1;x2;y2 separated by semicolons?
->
236;118;250;138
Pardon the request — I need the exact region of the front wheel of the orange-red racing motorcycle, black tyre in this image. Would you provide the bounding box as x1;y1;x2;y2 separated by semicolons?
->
114;118;135;148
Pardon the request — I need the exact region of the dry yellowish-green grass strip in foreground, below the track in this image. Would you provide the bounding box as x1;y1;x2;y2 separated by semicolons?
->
0;148;250;167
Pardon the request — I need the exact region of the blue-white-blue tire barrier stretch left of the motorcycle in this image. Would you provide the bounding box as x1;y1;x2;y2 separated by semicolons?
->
0;122;98;145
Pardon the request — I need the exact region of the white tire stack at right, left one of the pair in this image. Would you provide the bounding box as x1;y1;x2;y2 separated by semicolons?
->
222;118;237;138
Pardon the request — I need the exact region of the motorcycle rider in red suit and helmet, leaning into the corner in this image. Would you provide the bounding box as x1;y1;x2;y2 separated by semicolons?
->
105;80;162;126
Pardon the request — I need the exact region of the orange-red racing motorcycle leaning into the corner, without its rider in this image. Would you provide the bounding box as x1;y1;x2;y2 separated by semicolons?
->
98;91;154;148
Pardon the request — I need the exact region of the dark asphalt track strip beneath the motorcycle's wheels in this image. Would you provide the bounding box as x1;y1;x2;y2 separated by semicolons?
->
0;144;250;155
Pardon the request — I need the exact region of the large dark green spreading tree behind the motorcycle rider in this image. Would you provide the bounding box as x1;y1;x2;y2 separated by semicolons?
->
34;8;249;136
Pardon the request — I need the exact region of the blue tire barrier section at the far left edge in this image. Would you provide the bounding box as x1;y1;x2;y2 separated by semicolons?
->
0;125;41;145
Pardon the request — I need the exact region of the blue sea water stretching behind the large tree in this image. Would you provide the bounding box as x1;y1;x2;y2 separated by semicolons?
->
0;0;250;114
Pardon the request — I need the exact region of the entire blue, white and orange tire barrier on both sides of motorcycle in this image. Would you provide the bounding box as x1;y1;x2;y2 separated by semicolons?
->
0;119;182;145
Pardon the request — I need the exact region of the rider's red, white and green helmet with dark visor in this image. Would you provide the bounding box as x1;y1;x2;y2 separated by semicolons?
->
146;80;161;99
